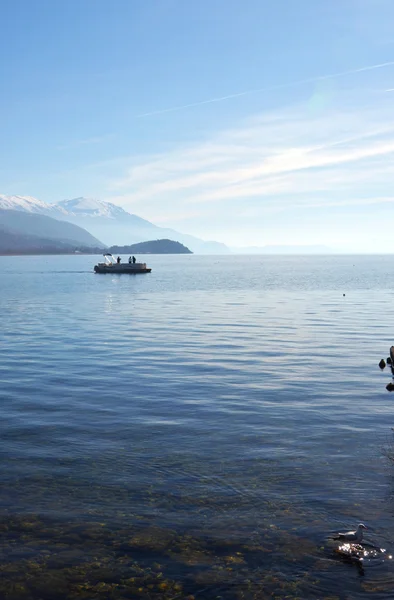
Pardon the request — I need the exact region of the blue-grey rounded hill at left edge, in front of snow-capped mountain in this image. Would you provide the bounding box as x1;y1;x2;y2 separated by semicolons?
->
0;209;105;248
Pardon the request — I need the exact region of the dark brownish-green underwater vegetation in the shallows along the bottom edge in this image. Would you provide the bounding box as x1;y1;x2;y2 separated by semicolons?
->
0;514;382;600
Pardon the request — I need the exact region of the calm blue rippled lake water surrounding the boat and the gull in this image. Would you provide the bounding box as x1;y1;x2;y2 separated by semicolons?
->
0;256;394;600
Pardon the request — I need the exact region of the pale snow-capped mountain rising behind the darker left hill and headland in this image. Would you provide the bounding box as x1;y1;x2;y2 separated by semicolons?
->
0;195;229;254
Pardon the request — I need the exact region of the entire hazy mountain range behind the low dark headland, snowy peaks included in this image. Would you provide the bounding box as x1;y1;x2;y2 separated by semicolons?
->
0;194;335;254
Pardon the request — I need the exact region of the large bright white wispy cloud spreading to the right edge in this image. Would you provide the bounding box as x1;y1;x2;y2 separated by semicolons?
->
105;86;394;248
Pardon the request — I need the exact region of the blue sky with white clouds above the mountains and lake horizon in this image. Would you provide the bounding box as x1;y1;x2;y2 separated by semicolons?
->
0;0;394;252
